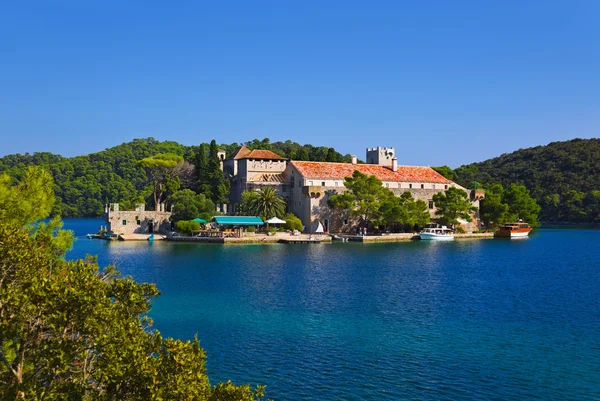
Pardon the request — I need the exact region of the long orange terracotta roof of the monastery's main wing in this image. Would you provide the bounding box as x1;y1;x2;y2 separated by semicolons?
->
290;160;452;184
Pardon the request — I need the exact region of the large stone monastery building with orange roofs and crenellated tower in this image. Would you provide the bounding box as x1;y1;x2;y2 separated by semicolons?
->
224;146;483;232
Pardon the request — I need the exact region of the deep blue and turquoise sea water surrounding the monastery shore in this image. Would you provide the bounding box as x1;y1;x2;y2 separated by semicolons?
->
66;220;600;400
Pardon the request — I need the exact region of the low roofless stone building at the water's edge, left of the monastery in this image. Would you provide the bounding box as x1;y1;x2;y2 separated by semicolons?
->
104;203;171;234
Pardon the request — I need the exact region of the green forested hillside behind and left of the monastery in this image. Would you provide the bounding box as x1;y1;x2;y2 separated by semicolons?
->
0;138;351;217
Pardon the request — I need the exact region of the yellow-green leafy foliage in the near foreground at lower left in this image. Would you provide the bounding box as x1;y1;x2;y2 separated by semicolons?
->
0;165;264;401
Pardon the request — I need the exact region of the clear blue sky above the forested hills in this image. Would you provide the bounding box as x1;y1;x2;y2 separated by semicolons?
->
0;0;600;167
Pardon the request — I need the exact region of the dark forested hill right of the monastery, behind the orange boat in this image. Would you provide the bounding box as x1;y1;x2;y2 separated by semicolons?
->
450;138;600;223
